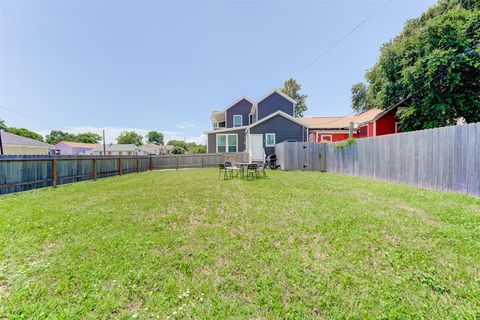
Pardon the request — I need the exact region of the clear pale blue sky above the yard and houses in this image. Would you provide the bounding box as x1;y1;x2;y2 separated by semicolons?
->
0;0;436;142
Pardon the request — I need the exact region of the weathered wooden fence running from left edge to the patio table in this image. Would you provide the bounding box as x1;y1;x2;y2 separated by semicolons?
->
0;153;248;194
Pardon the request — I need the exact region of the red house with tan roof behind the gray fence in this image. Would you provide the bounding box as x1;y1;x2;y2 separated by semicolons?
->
303;107;398;142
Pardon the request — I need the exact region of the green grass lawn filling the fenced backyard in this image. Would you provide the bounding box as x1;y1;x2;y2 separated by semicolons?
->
0;169;480;319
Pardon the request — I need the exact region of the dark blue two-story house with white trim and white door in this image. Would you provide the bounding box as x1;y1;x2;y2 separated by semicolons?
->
205;90;308;161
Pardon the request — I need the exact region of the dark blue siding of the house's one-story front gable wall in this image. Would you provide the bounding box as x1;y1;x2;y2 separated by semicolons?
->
250;115;307;156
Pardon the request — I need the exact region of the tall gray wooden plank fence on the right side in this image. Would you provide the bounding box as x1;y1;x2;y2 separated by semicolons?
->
275;123;480;196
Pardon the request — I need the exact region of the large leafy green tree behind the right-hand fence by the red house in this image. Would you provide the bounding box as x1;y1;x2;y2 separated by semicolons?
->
352;0;480;131
